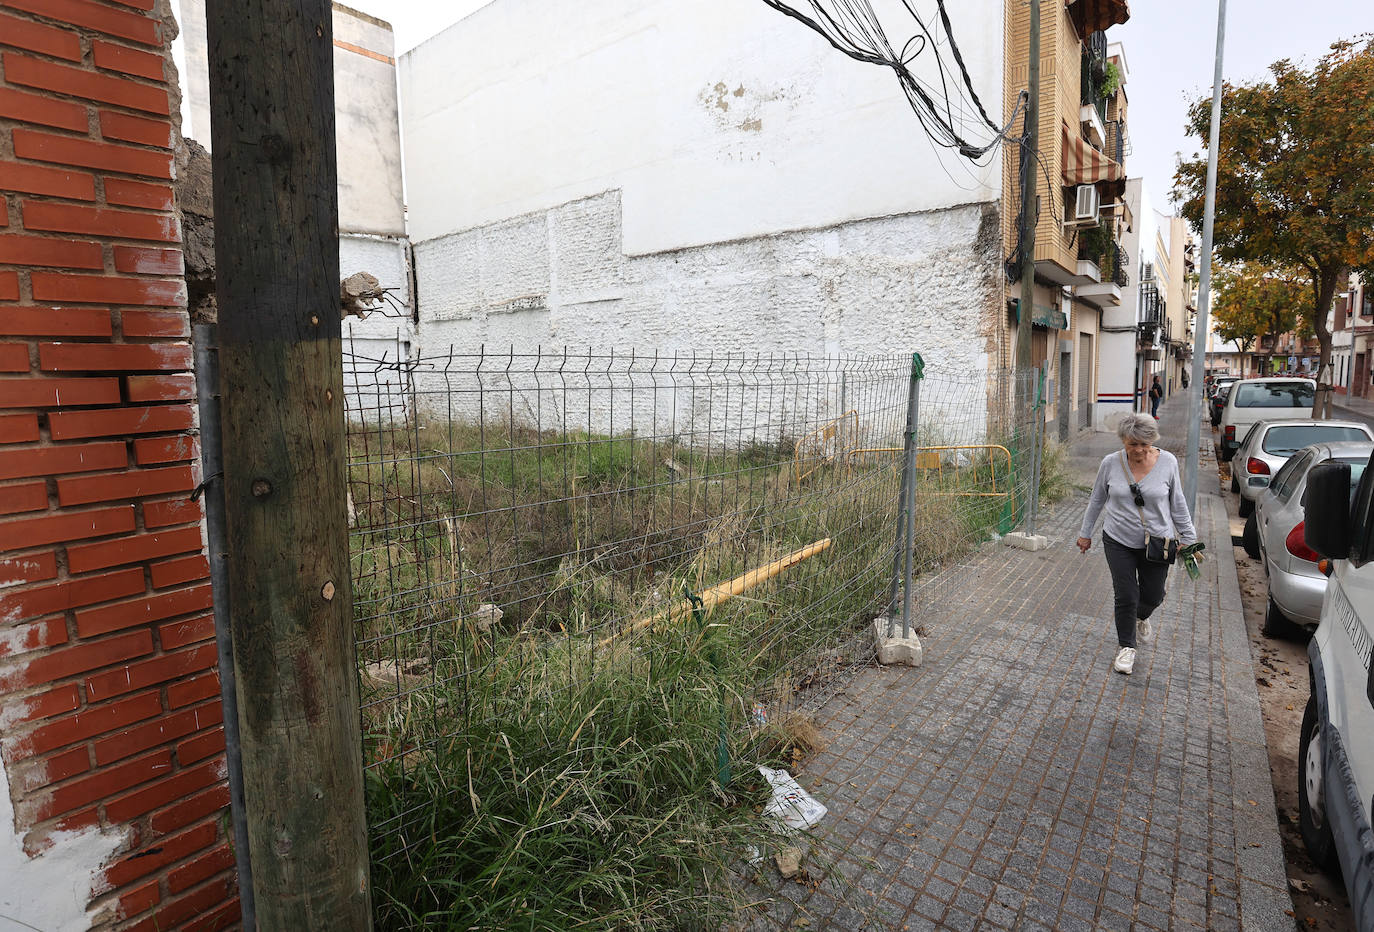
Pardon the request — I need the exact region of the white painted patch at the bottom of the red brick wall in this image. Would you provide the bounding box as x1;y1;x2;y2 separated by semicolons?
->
0;758;125;932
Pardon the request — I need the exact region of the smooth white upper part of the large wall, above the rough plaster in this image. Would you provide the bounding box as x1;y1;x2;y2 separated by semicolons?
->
400;0;1002;255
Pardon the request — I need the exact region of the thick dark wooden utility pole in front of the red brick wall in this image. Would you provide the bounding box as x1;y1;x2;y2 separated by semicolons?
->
206;0;371;932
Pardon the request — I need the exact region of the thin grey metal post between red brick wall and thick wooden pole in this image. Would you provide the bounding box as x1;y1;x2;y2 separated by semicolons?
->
194;323;257;929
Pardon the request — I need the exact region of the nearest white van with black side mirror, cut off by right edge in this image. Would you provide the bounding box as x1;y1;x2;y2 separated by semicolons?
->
1298;455;1374;932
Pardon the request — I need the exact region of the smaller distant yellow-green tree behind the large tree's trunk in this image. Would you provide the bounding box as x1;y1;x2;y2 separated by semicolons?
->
1212;264;1307;371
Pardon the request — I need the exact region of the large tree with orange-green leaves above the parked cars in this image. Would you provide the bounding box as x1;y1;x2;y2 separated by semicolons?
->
1175;40;1374;417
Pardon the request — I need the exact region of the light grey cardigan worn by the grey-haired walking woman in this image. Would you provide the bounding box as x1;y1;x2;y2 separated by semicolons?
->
1079;450;1198;547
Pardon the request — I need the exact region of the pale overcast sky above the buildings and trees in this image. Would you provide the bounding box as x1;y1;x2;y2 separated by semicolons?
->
342;0;1374;218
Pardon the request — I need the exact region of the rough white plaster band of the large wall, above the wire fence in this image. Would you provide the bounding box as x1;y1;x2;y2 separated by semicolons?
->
415;191;1002;429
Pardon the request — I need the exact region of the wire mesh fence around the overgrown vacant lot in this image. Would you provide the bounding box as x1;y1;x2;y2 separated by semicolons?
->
345;343;1035;929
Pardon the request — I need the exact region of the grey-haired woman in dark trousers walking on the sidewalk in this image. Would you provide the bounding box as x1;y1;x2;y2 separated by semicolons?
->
1079;414;1197;675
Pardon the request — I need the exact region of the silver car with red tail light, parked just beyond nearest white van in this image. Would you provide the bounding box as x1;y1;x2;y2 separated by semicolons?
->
1243;441;1374;638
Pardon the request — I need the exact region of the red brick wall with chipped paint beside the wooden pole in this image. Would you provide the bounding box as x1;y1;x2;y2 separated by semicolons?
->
0;0;238;931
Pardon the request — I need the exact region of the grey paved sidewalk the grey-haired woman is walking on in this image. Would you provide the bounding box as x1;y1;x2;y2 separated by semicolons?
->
756;396;1293;932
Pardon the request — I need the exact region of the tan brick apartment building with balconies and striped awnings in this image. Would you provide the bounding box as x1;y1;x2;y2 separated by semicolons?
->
1002;0;1132;436
